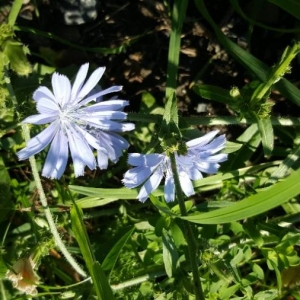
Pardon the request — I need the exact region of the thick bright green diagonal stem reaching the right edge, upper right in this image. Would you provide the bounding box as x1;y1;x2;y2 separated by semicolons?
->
251;43;300;103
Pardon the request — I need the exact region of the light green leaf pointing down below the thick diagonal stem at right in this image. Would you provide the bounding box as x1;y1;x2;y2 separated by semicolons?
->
257;118;274;157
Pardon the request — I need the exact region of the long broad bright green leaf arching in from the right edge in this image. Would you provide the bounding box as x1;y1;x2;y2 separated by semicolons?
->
181;169;300;224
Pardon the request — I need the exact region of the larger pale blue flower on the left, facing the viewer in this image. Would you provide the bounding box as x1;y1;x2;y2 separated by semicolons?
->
17;64;134;178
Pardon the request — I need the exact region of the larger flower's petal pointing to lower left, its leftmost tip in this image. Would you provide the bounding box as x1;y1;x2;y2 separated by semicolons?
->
17;122;59;160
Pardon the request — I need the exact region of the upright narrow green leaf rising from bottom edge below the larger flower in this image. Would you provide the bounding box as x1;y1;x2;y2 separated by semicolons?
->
70;203;114;300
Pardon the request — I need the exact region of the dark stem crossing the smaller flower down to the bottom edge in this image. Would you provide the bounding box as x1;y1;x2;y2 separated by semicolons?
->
170;153;205;300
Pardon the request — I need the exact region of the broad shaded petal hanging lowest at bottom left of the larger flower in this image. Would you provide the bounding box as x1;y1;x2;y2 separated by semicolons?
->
42;130;69;179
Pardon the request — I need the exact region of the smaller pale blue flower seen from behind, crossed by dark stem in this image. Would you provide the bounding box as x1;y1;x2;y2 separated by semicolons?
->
123;130;227;202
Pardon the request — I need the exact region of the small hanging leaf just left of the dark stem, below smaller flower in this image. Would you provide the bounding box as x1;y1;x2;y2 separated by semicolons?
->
162;229;178;277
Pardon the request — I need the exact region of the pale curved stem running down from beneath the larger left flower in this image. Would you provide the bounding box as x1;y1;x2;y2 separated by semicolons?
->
22;124;87;277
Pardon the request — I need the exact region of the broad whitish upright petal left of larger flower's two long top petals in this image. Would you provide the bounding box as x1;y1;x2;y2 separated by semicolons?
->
52;73;71;107
